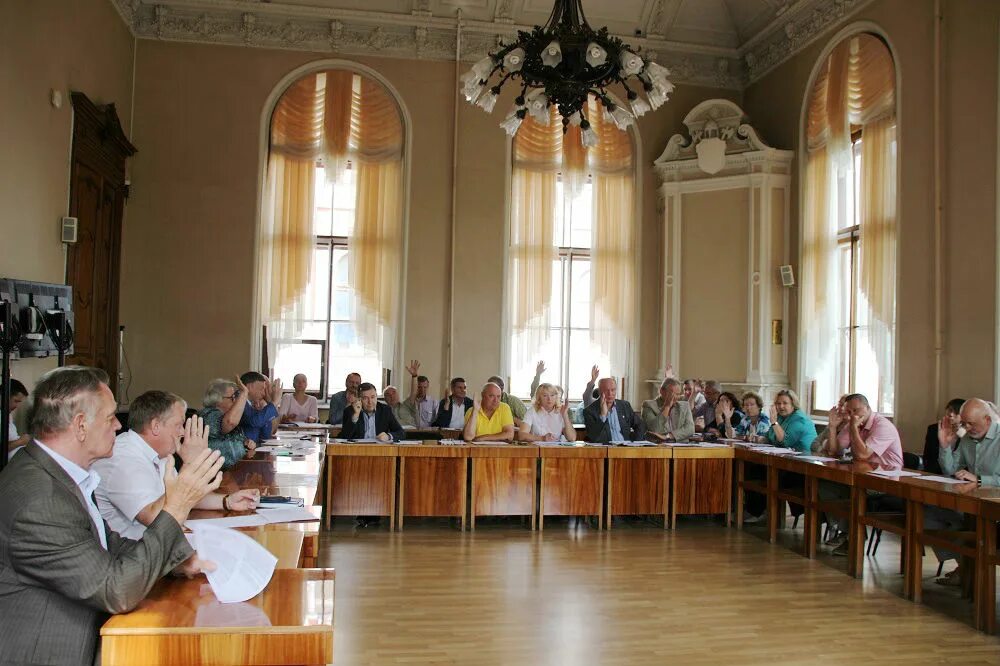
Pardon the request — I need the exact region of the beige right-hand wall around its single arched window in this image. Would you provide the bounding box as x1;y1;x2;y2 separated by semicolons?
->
744;0;1000;450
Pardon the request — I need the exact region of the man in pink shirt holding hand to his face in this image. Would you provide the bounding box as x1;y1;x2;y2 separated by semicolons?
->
819;393;903;555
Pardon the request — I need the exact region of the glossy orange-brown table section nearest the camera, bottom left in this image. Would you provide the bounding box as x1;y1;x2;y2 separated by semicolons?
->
101;569;334;666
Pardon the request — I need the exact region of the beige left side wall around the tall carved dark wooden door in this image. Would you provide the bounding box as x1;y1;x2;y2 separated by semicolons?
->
0;0;132;388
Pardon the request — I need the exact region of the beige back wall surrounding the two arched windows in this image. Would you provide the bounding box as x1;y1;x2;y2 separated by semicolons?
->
121;40;736;408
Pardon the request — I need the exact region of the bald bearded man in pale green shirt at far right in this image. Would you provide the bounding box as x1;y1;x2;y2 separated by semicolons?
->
924;398;1000;585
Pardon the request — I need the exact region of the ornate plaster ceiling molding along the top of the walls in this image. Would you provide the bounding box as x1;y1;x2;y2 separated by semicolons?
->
110;0;871;90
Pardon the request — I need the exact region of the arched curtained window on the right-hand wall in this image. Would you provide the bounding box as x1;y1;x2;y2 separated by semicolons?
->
800;33;898;413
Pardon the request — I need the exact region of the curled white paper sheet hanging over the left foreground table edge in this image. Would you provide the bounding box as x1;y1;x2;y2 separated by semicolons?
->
193;521;278;604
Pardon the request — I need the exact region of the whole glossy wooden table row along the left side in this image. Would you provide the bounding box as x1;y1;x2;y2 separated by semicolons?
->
101;444;335;666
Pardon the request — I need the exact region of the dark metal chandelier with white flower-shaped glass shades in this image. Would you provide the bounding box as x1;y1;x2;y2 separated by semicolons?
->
462;0;674;147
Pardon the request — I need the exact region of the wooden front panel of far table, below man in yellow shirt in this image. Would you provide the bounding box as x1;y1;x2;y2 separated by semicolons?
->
469;444;538;529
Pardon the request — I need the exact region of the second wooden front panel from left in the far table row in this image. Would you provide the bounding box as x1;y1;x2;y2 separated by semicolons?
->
397;444;469;529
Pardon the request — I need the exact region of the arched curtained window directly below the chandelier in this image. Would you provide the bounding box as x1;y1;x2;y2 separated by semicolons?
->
507;98;636;398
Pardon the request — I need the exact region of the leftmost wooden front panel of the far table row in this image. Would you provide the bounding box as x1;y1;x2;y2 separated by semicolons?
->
325;444;399;529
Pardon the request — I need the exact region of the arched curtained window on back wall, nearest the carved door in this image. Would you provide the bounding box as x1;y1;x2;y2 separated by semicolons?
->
258;69;405;398
